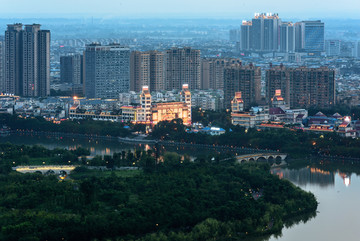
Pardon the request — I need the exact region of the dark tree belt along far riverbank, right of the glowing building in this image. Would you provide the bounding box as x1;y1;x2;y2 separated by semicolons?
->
151;119;360;158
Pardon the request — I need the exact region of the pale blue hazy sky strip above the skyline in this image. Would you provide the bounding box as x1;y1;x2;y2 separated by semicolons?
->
0;0;360;18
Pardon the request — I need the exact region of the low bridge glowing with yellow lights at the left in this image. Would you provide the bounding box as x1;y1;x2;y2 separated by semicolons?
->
12;165;76;175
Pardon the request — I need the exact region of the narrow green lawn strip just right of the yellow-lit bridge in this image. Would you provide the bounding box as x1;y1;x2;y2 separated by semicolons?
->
70;169;142;179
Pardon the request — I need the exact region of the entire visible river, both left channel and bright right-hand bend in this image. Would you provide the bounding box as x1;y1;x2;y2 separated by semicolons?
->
0;135;360;241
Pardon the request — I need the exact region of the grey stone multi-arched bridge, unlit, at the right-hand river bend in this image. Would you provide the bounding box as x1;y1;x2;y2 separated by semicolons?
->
235;153;287;165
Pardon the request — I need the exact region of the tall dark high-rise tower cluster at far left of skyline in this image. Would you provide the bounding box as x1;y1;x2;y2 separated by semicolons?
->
4;23;50;96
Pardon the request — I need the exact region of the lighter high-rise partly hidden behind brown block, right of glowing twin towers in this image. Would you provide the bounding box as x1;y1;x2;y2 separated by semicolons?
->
201;58;241;90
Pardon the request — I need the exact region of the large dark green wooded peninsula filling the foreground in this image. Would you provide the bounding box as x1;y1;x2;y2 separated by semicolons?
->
0;148;317;240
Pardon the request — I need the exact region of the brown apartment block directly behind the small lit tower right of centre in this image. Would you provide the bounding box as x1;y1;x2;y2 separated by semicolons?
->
224;64;261;109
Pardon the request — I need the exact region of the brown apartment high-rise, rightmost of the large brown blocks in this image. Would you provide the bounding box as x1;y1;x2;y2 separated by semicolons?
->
288;67;335;108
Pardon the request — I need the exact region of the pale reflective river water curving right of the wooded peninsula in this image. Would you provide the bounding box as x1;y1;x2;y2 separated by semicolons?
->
269;165;360;241
